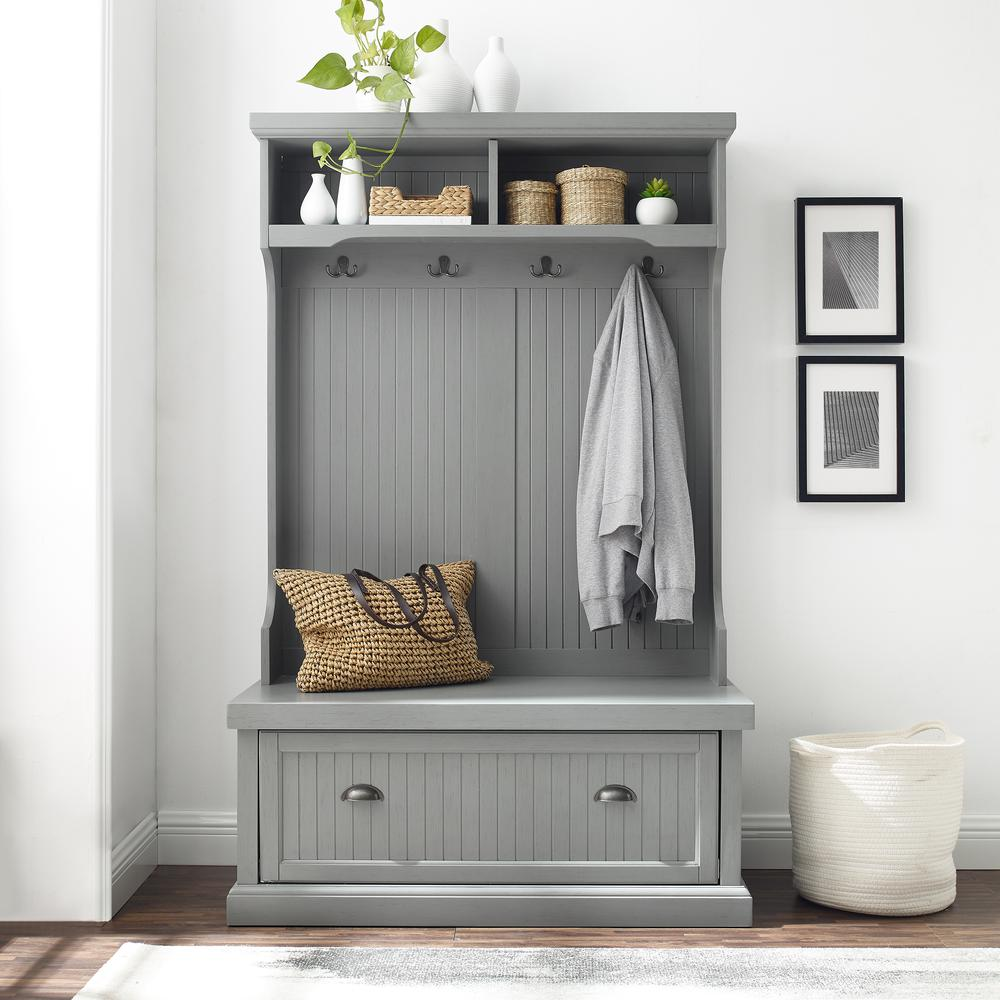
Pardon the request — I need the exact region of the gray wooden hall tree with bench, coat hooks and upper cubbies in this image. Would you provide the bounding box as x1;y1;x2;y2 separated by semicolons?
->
228;113;754;927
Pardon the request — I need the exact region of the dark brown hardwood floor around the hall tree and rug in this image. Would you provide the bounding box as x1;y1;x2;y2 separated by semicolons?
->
0;867;1000;1000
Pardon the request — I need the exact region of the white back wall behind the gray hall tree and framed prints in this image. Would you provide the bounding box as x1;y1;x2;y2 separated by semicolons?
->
158;0;1000;864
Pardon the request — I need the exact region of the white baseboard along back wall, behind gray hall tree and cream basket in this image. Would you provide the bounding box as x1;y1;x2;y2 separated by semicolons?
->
148;812;1000;869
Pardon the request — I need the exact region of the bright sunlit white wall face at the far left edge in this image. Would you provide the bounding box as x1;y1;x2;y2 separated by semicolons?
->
0;0;107;920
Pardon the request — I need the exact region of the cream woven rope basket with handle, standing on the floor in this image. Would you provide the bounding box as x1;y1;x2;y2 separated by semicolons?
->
789;722;965;916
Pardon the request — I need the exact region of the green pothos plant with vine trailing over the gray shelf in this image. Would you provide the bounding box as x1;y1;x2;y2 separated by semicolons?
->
299;0;445;177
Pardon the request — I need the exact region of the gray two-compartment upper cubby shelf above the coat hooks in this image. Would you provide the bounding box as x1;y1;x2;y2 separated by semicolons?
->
250;113;736;247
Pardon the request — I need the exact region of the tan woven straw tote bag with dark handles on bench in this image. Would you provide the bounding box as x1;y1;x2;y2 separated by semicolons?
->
274;561;493;691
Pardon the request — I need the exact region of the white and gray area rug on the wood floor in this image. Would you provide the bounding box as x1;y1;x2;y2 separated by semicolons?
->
77;944;1000;1000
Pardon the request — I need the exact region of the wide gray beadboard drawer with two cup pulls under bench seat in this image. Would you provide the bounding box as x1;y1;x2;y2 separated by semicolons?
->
259;732;719;884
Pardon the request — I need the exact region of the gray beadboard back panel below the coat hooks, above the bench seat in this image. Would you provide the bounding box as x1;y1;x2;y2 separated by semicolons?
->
275;247;712;674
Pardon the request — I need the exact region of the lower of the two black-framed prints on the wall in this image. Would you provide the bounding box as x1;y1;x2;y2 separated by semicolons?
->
798;356;906;503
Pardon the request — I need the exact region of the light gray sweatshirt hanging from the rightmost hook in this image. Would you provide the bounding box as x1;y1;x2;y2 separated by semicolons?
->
576;265;694;630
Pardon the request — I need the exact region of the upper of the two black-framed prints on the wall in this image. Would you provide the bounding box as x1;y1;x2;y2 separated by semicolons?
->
795;198;903;344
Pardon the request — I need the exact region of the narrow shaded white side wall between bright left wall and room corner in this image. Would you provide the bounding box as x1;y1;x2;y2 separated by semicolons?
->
108;0;156;909
